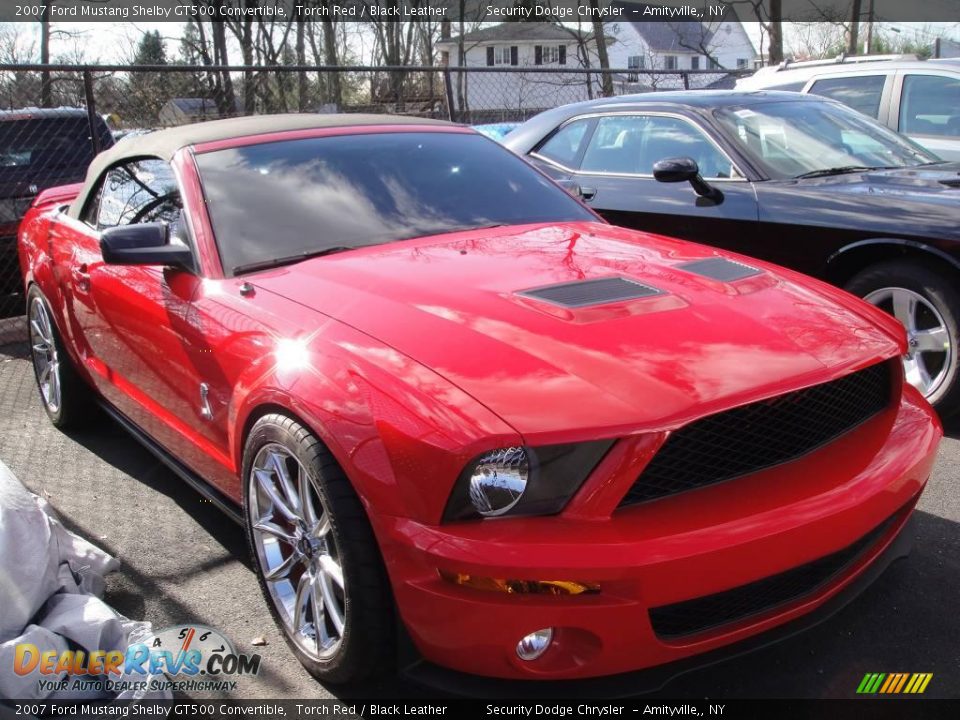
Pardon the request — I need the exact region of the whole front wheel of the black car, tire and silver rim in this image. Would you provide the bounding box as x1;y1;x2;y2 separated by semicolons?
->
846;262;960;417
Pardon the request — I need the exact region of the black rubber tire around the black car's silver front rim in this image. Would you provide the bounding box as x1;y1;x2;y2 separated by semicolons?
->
846;262;960;418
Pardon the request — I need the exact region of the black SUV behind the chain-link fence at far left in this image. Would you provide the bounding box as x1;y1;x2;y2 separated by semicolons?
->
0;108;113;318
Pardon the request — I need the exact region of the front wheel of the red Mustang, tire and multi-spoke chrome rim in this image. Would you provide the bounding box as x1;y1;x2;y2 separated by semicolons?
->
243;414;395;683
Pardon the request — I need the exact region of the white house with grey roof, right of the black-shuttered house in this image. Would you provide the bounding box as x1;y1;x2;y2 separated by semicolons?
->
608;0;760;87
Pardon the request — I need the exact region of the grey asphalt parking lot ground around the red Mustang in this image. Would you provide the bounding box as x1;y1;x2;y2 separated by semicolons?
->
0;336;960;699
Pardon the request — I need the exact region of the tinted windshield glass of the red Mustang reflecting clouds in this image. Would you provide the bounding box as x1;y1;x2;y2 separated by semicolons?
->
197;132;596;275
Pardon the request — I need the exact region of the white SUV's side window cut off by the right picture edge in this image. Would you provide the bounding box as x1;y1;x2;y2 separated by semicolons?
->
900;75;960;137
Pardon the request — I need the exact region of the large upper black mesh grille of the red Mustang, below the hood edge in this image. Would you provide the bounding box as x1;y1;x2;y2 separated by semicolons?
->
620;362;892;507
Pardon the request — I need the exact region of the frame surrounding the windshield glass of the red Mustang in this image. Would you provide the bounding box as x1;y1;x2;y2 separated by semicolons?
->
191;128;606;278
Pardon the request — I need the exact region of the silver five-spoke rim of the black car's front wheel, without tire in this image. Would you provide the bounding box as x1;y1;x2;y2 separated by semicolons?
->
864;287;956;398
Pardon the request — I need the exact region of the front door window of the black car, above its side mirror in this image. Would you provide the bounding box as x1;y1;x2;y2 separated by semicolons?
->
582;115;739;179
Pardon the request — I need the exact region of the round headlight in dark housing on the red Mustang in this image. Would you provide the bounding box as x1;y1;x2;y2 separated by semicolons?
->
443;440;613;521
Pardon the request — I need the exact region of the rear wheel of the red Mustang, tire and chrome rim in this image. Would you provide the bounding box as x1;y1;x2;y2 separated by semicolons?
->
27;285;93;430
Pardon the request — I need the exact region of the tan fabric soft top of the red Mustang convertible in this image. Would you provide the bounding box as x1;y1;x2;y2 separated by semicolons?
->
68;113;451;218
